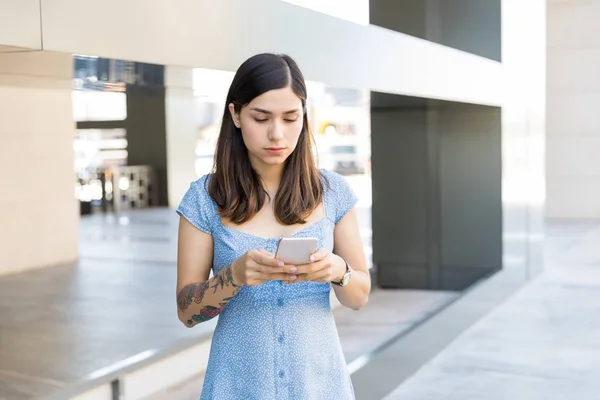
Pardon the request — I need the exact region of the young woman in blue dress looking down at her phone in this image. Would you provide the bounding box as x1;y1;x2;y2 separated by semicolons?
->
177;54;371;400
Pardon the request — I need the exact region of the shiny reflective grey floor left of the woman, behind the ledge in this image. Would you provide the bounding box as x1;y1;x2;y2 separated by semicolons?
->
0;260;213;400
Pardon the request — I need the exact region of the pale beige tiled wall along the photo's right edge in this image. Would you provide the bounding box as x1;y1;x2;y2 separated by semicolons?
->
547;0;600;218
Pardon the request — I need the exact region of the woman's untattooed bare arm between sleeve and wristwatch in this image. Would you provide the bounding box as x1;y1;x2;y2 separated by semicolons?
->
332;208;371;310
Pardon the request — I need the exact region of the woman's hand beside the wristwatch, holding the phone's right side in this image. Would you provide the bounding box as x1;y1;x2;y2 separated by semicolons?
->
287;249;346;283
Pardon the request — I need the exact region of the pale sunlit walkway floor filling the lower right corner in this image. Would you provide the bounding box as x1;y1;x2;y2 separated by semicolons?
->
385;221;600;400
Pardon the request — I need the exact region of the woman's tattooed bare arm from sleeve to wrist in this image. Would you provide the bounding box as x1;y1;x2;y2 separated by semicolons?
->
177;217;242;328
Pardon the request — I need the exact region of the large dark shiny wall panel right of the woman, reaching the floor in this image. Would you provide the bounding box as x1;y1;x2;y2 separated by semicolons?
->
371;97;502;290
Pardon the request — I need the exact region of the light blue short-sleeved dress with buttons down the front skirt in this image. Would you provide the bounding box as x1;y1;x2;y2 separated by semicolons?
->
177;170;357;400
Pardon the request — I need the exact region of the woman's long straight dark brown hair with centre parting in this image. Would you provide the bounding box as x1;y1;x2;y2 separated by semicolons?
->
208;54;325;225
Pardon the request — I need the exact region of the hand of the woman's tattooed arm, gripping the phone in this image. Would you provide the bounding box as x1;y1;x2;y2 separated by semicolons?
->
231;250;297;286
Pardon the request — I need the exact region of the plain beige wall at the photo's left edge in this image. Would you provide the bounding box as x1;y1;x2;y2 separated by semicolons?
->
0;52;79;275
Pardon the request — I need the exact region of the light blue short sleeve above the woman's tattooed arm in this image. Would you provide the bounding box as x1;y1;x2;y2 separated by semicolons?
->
177;175;214;234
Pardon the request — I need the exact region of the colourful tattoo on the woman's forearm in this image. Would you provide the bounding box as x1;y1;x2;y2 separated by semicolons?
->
177;267;242;326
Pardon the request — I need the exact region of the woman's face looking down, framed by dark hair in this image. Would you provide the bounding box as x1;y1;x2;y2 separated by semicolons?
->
229;87;304;168
